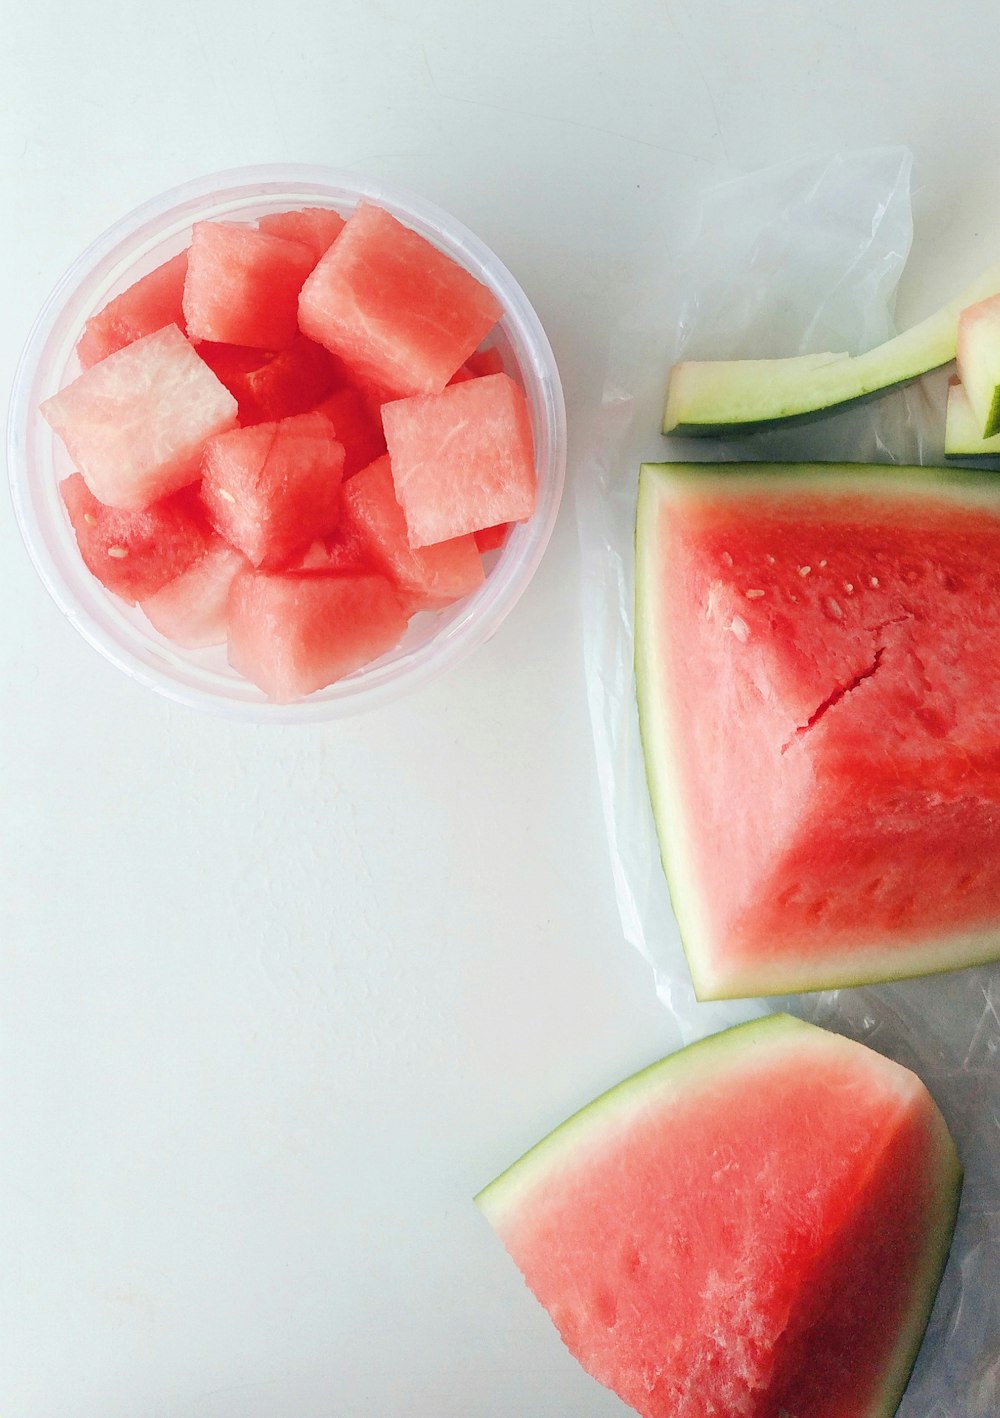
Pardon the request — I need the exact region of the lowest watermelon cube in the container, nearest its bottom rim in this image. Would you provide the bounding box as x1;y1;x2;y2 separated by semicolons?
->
228;571;406;703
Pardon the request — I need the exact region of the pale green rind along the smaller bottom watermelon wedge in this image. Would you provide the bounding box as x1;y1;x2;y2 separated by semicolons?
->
474;1014;962;1418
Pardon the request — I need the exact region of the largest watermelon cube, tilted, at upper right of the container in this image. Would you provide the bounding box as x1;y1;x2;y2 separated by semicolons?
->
299;203;502;396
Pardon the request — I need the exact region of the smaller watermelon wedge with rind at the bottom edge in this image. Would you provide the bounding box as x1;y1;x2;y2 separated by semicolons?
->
477;1015;960;1418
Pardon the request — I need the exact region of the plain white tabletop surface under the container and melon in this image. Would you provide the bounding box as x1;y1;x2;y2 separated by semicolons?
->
0;0;1000;1418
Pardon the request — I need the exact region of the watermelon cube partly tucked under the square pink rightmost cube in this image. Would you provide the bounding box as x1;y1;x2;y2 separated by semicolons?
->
343;455;484;611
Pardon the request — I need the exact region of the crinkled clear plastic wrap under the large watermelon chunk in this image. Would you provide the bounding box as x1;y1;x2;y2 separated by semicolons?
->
576;147;1000;1418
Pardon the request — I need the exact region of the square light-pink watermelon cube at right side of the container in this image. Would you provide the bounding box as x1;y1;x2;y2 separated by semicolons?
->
382;374;536;546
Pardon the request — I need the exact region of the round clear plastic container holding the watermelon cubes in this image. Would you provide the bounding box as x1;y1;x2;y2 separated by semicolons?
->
7;166;566;722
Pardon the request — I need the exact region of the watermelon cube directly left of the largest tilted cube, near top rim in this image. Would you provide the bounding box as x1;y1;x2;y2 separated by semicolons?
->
184;221;316;350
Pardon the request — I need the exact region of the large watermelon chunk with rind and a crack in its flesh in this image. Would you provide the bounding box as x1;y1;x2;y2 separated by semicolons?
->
635;464;1000;998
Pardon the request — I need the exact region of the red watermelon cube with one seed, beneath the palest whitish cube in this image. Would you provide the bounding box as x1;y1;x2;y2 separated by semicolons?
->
60;472;209;605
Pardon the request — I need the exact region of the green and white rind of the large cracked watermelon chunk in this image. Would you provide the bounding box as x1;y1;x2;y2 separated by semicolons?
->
634;462;1000;1000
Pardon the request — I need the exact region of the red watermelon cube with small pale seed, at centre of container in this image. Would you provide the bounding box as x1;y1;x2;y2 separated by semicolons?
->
201;413;343;567
